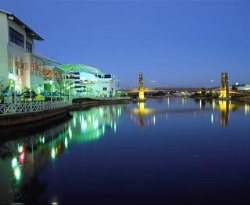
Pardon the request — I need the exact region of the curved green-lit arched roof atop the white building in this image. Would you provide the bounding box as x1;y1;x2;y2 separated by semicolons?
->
57;64;105;75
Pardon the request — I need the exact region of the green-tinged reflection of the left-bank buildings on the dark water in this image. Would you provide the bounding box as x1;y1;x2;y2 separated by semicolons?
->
0;105;126;204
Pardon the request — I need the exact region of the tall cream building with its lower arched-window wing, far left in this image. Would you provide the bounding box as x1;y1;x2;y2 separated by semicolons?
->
0;10;62;94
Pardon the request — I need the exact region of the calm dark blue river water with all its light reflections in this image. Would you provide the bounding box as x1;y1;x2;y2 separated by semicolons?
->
0;98;250;204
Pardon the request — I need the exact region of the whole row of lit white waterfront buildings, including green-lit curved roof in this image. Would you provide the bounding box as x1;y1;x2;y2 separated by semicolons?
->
0;10;118;97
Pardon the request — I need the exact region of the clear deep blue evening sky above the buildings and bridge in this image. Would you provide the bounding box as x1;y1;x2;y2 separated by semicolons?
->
0;0;250;88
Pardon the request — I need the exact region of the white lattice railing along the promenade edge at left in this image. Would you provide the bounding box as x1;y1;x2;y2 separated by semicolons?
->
0;101;72;115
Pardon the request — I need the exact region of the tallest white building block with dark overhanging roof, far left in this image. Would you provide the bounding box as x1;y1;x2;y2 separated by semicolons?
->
0;10;43;92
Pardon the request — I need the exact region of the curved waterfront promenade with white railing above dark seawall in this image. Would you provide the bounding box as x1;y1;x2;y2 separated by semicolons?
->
0;97;130;128
